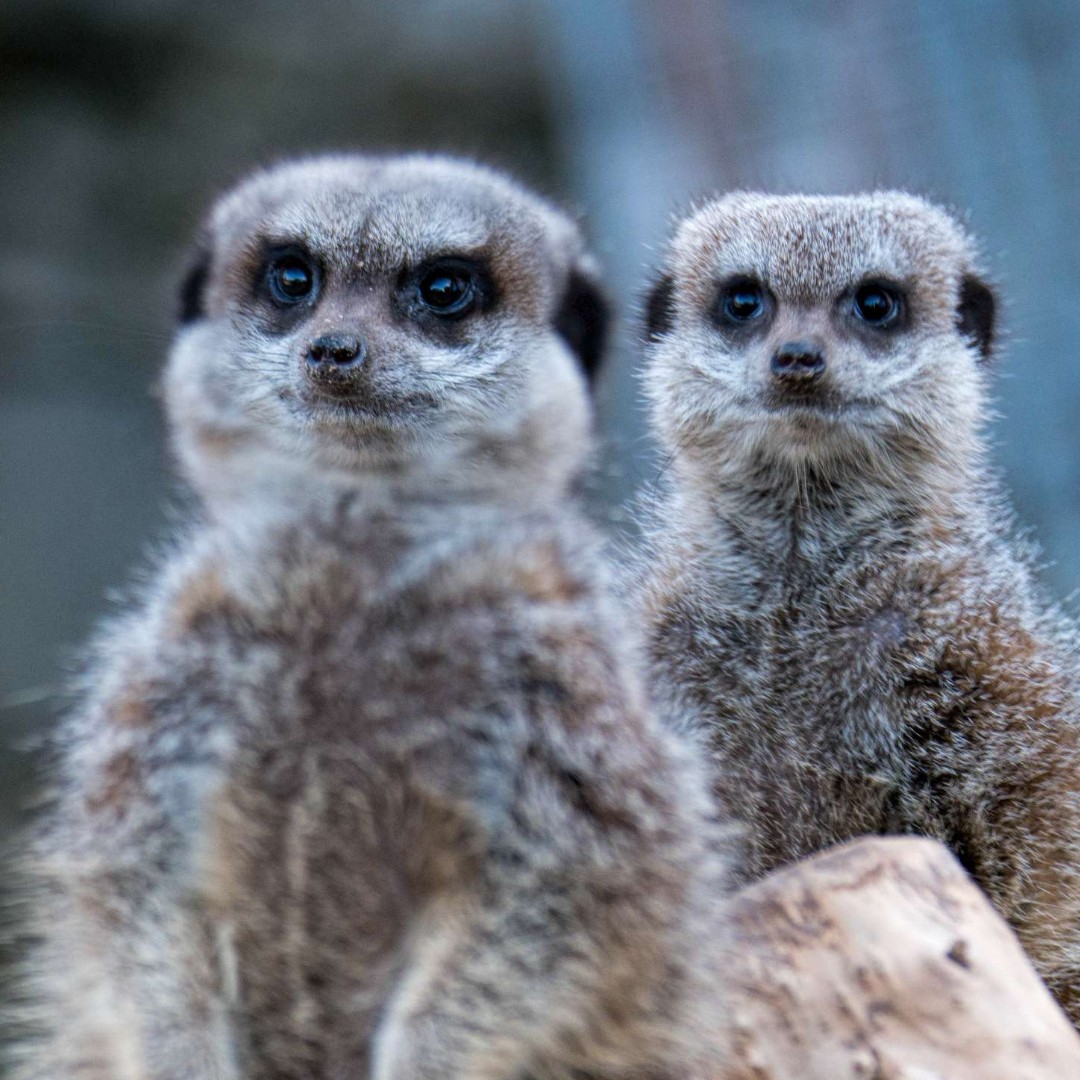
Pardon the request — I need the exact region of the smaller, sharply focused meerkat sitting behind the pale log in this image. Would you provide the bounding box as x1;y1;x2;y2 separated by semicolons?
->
639;192;1080;1021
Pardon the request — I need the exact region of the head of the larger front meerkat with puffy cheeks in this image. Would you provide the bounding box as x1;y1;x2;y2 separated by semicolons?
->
165;156;606;498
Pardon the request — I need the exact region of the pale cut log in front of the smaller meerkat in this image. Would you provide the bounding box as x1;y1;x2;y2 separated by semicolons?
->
717;838;1080;1080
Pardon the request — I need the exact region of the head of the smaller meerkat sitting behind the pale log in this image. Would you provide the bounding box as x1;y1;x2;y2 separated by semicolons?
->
648;192;995;481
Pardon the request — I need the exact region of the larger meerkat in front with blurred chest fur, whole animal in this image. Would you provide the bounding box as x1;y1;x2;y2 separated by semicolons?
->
12;157;721;1080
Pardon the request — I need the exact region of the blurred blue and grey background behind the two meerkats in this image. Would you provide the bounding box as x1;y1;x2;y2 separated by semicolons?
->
0;0;1080;972
